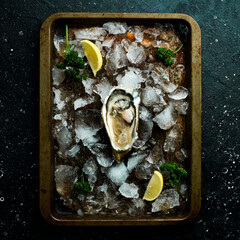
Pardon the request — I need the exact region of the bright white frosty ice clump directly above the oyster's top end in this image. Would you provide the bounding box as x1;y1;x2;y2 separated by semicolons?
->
116;67;145;89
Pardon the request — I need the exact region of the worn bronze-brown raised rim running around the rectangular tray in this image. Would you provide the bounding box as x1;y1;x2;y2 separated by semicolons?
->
39;12;202;226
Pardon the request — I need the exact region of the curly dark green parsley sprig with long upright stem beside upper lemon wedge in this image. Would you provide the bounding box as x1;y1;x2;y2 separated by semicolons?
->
56;25;88;81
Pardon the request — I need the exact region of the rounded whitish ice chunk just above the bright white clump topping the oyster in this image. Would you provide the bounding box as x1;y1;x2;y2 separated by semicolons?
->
127;42;146;65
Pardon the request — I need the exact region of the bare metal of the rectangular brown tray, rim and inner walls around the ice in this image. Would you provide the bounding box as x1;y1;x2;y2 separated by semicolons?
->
39;13;202;226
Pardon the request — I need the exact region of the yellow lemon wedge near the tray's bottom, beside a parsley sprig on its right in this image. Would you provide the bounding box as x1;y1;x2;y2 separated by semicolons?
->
143;171;163;201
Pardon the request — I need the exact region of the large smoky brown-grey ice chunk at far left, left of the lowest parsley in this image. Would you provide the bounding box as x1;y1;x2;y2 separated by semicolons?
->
55;165;78;196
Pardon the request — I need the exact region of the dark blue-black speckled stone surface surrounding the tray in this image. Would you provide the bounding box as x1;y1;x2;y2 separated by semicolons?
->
0;0;240;240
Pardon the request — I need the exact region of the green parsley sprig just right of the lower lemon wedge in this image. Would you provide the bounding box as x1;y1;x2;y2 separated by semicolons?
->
159;163;187;194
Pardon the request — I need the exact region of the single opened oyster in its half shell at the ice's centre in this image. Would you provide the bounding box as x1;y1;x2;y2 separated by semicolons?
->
102;85;140;163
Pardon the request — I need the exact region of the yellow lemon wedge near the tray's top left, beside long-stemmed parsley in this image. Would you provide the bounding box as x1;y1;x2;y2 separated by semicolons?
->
81;40;102;77
